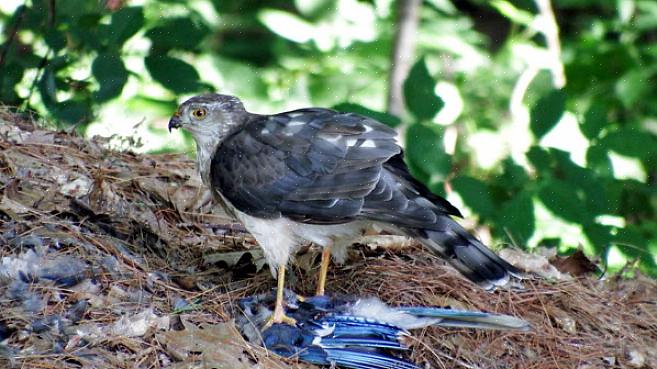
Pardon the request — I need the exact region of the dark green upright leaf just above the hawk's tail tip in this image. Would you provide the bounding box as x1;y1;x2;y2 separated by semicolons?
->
496;191;536;246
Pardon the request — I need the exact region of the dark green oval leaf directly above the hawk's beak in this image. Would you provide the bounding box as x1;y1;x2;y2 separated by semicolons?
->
145;55;201;94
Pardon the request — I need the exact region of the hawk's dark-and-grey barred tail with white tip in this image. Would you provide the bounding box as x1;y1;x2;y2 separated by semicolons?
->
409;216;522;290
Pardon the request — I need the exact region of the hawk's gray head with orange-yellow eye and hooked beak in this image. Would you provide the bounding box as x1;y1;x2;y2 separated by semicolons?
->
169;94;248;139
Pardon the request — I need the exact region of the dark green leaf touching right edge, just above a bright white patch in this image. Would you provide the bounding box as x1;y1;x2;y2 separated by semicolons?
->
601;128;657;159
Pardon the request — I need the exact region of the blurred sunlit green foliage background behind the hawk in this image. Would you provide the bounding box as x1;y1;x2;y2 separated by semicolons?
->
0;0;657;275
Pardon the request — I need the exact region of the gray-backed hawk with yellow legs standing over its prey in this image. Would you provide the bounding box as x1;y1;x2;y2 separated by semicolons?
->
169;94;520;324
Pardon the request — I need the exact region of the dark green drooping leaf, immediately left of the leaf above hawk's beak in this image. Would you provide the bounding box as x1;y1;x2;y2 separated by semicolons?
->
91;53;128;102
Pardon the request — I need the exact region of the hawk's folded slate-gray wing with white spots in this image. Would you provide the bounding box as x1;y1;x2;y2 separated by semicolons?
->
211;109;459;226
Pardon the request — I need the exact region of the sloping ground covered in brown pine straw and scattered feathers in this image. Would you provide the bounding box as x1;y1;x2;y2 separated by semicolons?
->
0;112;657;369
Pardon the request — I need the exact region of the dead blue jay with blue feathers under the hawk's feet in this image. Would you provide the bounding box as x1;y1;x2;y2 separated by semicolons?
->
236;290;529;369
